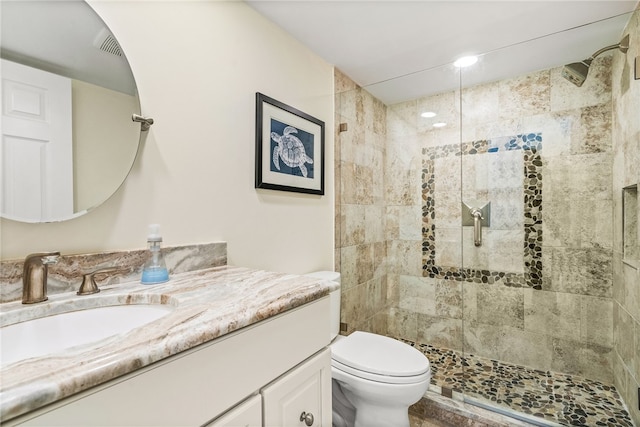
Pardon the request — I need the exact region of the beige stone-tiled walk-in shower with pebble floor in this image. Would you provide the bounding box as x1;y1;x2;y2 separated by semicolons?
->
336;8;640;426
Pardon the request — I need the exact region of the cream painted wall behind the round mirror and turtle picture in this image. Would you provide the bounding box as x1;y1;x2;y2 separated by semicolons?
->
0;0;334;273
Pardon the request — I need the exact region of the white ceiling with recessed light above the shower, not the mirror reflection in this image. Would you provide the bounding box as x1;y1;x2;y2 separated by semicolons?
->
246;0;639;105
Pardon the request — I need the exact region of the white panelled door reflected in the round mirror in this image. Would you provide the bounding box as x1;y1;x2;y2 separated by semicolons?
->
0;60;73;222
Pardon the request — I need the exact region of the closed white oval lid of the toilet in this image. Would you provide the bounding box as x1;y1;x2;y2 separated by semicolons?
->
331;331;429;377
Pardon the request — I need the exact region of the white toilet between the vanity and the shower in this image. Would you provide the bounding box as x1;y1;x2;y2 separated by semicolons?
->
307;271;431;427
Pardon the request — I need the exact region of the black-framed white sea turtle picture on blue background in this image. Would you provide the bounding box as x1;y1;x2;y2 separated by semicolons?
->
255;92;324;195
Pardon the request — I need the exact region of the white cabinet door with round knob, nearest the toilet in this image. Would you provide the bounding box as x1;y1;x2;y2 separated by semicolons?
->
262;349;331;427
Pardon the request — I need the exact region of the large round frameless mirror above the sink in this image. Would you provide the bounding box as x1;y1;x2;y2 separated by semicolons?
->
0;0;140;223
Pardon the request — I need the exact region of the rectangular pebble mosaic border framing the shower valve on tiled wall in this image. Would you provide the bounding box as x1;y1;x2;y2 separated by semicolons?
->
422;133;542;289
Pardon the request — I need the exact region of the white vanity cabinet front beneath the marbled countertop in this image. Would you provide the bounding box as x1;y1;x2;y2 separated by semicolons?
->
8;297;331;427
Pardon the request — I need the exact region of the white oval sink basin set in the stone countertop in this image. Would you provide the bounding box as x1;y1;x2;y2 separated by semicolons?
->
0;305;172;366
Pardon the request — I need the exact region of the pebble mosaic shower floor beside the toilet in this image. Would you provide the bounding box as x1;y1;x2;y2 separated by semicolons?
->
403;340;634;427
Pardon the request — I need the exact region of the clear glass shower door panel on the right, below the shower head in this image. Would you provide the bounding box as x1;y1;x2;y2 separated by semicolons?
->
461;15;624;425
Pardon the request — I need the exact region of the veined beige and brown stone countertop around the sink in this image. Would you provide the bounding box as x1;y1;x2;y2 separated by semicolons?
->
0;266;338;421
